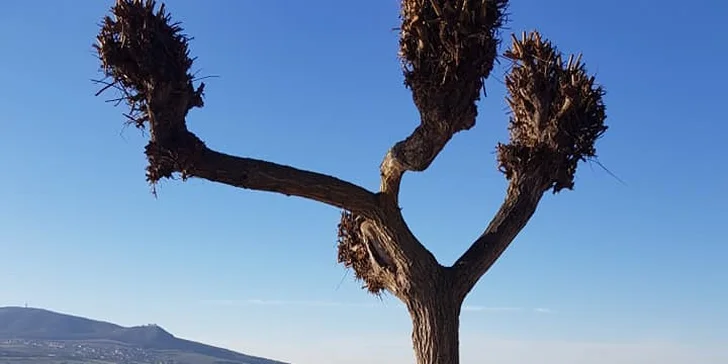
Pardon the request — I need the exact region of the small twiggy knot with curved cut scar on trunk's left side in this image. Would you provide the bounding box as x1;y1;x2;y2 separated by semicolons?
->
337;211;396;294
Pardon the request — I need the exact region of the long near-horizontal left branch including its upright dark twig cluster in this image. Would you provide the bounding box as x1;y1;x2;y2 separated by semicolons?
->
96;0;378;216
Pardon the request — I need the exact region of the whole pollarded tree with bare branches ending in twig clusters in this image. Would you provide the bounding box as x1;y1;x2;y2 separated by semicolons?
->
96;0;607;364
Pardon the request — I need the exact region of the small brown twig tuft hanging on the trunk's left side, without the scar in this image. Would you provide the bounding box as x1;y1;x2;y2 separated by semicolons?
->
337;211;384;294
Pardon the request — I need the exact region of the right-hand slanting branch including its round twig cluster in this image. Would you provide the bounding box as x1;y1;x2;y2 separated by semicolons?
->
454;32;607;297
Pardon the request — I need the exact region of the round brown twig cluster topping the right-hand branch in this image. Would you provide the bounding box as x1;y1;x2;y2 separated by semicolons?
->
498;32;607;192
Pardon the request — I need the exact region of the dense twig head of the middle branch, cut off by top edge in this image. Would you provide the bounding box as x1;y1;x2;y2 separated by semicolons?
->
399;0;508;134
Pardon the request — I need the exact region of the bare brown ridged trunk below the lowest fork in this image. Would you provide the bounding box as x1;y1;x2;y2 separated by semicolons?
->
407;287;461;364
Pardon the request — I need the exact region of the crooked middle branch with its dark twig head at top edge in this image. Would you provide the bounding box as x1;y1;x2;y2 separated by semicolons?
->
380;0;508;204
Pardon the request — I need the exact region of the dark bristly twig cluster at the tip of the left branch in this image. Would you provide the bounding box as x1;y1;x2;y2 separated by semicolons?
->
95;0;204;183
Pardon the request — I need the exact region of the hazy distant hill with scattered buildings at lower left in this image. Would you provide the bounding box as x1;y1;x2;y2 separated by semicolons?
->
0;307;282;364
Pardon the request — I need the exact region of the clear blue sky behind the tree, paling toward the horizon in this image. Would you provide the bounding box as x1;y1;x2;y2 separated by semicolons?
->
0;0;728;364
